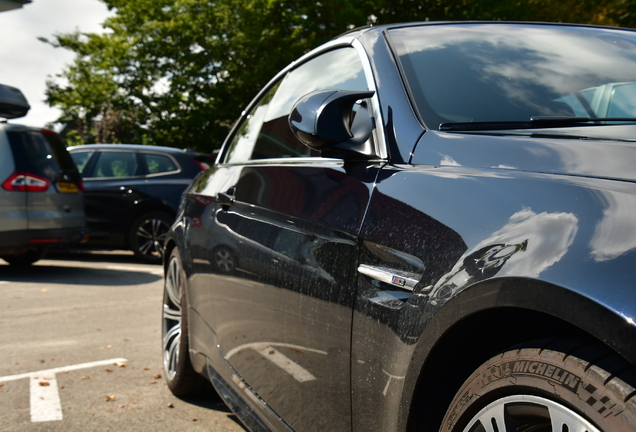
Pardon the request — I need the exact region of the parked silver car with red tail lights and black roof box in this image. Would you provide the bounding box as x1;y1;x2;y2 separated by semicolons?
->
0;84;86;266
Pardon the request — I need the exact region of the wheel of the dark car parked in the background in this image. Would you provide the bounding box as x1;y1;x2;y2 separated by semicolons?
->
128;211;174;263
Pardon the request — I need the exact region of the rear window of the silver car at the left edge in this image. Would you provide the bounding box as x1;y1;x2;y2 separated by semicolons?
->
7;129;77;181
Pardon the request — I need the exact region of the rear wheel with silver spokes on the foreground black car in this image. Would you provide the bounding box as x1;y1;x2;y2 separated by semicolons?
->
161;248;209;397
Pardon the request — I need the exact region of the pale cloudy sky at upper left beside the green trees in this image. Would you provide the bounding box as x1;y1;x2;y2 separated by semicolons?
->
0;0;110;127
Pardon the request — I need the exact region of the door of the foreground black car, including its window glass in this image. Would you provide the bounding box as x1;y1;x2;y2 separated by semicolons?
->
194;47;377;430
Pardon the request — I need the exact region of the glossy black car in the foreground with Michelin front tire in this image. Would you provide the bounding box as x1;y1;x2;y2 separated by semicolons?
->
163;22;636;432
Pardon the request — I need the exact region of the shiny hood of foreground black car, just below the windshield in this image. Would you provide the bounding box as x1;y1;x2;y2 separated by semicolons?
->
411;125;636;181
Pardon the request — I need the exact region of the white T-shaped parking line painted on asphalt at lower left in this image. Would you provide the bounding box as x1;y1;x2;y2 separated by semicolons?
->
0;358;128;423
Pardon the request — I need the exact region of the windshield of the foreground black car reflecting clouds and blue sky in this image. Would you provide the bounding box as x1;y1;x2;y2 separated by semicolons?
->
389;23;636;129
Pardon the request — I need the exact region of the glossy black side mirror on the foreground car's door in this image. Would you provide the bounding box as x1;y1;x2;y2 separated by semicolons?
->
289;90;375;159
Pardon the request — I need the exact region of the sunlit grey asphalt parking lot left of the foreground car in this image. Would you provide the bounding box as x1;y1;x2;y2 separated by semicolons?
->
0;251;244;431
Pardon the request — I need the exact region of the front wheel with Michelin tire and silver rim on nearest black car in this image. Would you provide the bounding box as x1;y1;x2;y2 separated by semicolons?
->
440;340;636;432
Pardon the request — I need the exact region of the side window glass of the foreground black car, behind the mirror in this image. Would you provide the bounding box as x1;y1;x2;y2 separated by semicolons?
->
225;48;368;163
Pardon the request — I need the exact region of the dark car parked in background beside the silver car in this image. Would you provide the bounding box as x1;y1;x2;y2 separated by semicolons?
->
68;144;208;262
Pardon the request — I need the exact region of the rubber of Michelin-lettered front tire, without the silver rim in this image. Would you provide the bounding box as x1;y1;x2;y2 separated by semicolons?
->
440;349;636;432
